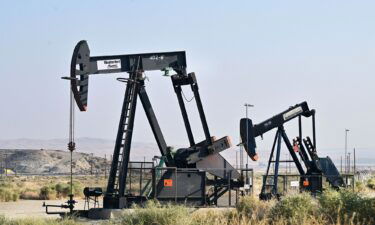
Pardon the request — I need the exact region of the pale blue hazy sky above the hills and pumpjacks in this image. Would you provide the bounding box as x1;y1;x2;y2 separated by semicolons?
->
0;0;375;155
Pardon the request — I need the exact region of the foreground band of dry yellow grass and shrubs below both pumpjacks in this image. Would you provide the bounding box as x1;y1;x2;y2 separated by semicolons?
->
107;190;375;225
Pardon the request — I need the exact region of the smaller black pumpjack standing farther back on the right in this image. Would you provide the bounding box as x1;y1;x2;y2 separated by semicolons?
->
240;102;345;200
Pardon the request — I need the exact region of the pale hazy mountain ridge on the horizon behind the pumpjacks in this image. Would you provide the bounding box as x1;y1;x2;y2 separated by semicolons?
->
0;137;375;168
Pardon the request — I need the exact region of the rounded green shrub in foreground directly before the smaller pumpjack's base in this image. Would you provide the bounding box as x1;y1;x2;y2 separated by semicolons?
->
269;193;317;224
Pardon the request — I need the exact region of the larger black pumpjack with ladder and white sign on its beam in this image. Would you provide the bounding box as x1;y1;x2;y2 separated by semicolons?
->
44;41;250;218
